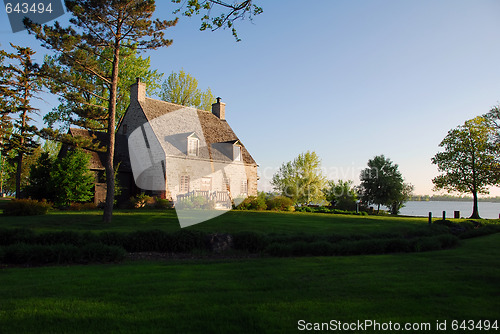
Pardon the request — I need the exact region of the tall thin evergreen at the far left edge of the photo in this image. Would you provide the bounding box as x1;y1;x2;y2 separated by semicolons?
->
0;43;41;198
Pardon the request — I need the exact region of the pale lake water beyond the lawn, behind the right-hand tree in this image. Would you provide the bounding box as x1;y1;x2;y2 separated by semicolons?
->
399;201;500;219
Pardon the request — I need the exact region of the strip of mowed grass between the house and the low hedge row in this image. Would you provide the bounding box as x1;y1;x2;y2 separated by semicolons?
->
0;210;438;234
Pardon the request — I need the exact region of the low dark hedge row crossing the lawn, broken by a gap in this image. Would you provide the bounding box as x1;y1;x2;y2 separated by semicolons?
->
0;224;500;264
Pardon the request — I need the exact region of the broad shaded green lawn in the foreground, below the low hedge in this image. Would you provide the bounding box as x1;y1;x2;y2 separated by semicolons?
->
0;234;500;333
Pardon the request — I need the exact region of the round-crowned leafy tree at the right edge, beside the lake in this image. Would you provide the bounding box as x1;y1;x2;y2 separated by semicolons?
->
432;117;500;219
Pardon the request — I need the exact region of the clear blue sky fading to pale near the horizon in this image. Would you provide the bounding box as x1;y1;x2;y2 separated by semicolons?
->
0;0;500;196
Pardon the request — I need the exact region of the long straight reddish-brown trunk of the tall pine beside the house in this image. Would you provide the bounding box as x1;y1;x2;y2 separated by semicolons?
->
103;39;120;223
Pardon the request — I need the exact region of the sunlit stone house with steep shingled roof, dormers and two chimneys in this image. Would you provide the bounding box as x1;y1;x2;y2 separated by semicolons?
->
66;79;258;207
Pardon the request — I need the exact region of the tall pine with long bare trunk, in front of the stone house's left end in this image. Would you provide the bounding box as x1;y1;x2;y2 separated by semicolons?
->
24;0;177;222
